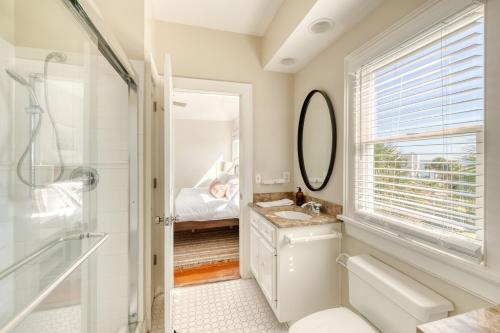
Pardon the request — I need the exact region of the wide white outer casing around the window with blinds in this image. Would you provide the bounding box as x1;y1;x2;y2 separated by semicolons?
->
339;0;500;303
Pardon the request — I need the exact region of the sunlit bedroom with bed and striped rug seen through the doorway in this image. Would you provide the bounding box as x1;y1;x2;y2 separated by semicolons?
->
172;89;240;286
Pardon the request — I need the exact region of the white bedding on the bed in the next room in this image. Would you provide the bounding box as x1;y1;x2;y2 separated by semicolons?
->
175;188;240;222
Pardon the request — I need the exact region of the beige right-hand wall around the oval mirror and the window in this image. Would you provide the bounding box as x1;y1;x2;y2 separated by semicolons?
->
293;0;492;313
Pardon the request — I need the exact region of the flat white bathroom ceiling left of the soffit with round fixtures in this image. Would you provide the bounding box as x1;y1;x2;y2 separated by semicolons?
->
153;0;284;36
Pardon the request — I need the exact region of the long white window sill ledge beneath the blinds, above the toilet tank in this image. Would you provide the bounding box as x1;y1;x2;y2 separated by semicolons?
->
338;215;500;304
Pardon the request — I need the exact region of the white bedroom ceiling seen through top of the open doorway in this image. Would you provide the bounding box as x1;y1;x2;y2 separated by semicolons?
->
173;91;240;121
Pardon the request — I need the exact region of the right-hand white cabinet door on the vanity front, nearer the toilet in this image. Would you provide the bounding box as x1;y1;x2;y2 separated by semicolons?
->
259;237;276;307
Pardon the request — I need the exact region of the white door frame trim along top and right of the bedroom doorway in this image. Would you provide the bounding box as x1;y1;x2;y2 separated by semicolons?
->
173;77;253;278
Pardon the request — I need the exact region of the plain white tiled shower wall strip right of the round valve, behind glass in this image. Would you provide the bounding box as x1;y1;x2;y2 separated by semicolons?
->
91;57;130;333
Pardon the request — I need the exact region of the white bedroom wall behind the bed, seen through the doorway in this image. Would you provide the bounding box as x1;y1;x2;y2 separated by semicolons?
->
174;119;233;193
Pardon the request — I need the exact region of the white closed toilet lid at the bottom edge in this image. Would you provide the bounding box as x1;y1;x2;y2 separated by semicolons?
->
289;308;378;333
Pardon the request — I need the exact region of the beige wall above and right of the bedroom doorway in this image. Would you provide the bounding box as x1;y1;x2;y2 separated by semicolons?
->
154;21;293;192
